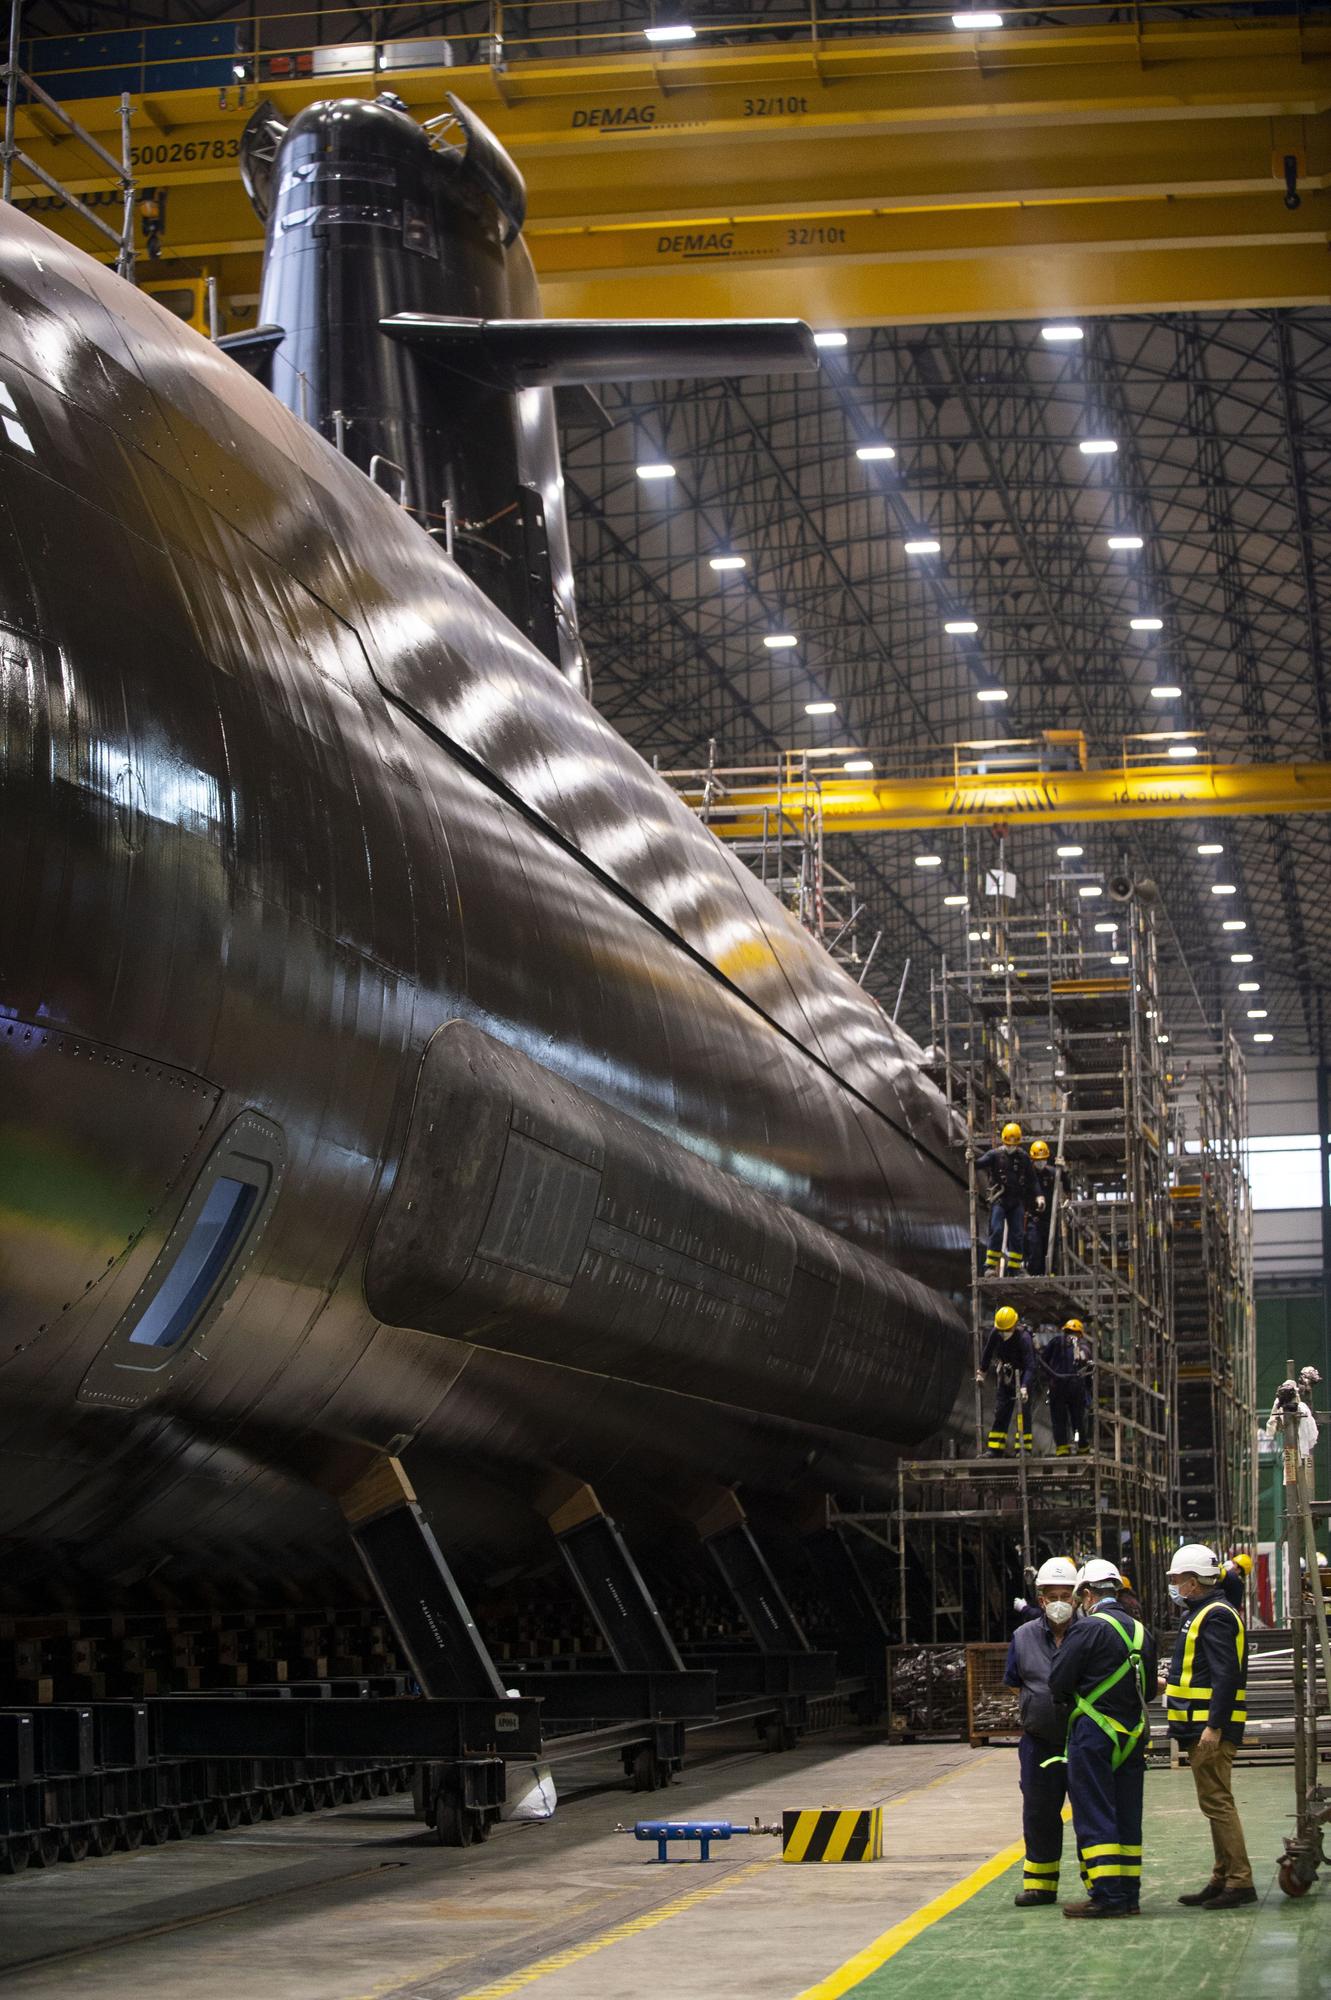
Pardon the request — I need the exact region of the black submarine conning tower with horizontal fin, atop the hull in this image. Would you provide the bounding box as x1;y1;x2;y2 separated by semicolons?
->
234;94;817;690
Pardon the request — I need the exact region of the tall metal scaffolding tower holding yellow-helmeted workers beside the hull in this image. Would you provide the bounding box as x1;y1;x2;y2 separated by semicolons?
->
841;834;1253;1642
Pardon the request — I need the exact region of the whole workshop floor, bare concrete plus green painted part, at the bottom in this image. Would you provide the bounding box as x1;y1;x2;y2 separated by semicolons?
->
0;1734;1331;2000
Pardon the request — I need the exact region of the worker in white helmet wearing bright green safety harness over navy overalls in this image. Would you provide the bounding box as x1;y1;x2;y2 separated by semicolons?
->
1049;1556;1155;1918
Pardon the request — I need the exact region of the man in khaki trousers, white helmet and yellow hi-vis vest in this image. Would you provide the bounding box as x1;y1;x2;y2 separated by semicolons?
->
1165;1542;1257;1910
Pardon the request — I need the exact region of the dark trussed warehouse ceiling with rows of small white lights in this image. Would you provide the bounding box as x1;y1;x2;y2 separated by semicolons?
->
566;318;1331;1054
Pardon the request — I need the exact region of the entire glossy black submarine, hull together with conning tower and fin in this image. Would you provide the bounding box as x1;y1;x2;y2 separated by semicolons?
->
0;98;969;1608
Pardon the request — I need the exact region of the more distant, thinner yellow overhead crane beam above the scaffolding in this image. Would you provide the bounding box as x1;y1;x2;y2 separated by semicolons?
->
662;730;1331;842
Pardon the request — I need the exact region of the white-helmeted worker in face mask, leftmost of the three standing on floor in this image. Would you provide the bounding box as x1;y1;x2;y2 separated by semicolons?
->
1003;1556;1077;1910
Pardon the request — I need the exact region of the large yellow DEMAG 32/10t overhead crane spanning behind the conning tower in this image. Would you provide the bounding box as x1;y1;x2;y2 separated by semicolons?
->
2;0;1331;326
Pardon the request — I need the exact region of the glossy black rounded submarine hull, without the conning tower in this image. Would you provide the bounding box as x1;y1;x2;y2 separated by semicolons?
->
0;180;967;1604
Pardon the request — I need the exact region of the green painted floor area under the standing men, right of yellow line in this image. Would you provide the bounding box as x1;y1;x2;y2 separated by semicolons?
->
849;1770;1331;2000
